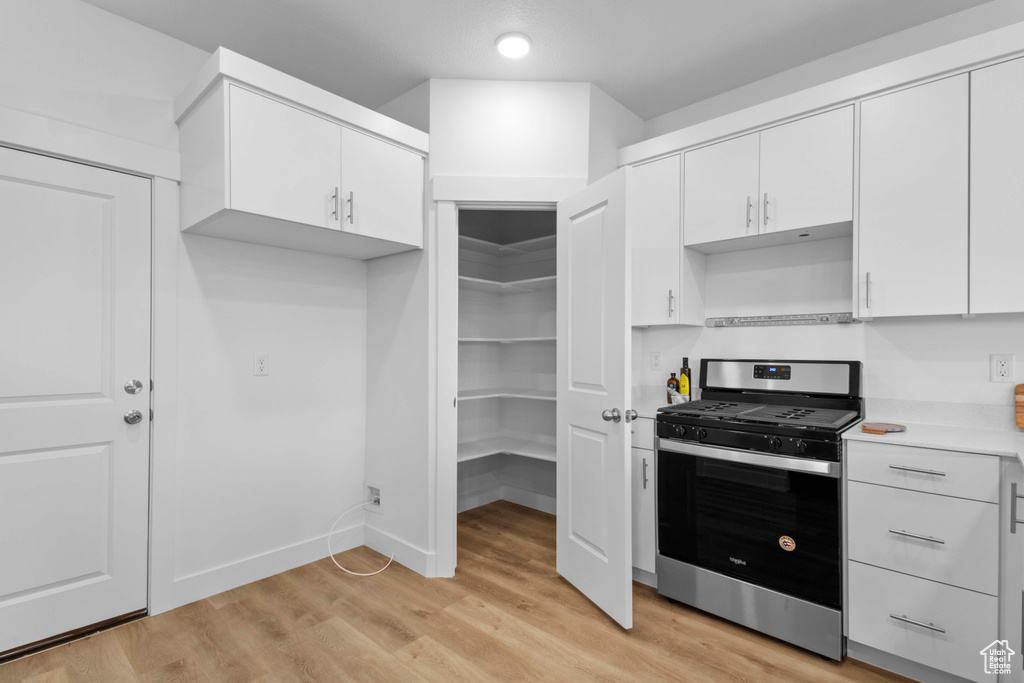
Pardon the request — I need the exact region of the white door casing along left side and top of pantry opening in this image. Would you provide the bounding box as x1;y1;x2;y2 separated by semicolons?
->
431;176;587;577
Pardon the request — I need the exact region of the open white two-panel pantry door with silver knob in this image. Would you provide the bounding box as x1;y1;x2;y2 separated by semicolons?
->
556;168;633;629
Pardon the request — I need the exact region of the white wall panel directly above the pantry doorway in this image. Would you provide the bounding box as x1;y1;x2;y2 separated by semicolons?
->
430;79;591;178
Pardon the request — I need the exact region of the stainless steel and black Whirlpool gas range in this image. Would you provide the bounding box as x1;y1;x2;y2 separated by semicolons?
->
655;358;862;659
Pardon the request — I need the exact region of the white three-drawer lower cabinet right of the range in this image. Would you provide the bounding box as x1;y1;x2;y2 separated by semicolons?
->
846;440;1021;681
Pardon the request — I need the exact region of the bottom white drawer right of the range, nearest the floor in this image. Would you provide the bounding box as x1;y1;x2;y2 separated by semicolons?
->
848;562;998;681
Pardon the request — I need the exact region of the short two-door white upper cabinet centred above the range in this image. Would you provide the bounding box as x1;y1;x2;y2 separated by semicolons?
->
683;106;853;251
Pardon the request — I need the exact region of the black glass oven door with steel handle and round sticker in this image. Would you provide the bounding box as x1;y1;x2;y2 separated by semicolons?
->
656;439;842;609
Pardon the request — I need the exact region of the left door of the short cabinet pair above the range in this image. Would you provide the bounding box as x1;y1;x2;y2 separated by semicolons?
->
683;133;759;245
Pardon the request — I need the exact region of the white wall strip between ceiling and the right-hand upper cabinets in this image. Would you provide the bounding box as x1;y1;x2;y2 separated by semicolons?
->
644;0;1024;139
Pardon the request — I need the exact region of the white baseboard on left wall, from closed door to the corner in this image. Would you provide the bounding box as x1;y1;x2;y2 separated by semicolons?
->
171;523;360;608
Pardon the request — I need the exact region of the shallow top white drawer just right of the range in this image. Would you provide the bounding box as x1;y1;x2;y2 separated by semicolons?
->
846;441;999;503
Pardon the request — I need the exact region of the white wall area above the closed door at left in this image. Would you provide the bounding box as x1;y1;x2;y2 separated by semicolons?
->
0;0;210;150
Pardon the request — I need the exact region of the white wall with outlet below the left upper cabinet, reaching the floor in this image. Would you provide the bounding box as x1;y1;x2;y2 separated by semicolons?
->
172;234;367;602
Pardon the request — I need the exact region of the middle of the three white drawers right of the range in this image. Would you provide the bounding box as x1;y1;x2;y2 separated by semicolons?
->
847;481;999;593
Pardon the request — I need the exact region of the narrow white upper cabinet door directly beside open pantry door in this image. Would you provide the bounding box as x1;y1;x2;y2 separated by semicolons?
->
629;155;682;326
